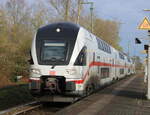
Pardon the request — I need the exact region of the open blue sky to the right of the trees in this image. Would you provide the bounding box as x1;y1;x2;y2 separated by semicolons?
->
92;0;150;58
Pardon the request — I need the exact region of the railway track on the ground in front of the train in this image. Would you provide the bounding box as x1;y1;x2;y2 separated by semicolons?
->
0;102;70;115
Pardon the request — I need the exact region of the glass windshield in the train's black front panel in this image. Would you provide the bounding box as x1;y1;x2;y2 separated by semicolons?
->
41;40;67;62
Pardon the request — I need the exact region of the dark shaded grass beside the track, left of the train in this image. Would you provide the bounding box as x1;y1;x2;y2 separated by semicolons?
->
0;85;34;110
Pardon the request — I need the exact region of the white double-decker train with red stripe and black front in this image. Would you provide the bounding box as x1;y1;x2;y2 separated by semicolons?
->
29;22;135;101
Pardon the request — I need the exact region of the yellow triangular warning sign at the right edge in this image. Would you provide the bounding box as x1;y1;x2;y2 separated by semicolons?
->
138;17;150;30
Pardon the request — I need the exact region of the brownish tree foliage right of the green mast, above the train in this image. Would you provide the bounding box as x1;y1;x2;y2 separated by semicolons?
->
94;18;122;50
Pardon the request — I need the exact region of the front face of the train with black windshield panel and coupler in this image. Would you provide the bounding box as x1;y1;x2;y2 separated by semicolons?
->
29;23;82;96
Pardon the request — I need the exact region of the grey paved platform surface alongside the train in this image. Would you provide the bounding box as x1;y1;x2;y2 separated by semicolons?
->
56;74;150;115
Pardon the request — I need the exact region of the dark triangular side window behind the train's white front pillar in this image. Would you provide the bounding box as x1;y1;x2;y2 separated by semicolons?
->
74;46;87;66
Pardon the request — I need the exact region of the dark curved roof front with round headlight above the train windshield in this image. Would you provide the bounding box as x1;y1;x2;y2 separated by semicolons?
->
37;22;80;38
